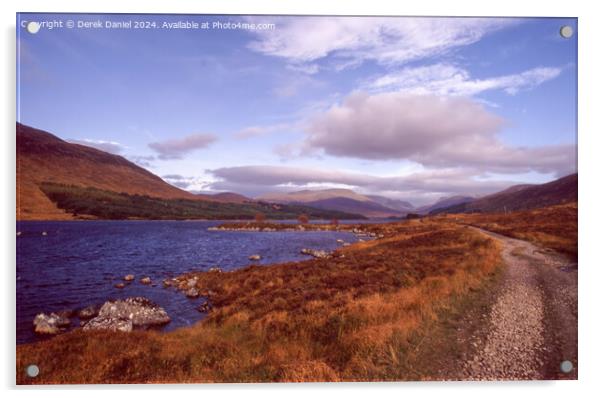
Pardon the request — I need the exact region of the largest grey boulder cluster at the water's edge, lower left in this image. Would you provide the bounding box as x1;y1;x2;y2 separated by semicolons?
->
84;297;171;332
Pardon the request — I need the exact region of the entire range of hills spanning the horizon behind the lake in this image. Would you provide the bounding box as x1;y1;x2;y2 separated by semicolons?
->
17;123;577;220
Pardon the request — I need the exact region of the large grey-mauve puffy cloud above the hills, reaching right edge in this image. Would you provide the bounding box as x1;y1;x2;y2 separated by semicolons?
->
305;92;576;174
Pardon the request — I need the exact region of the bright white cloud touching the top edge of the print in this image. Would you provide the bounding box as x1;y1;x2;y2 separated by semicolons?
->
249;17;520;70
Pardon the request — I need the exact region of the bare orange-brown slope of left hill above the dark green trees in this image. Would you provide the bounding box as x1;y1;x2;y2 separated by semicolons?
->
17;123;213;220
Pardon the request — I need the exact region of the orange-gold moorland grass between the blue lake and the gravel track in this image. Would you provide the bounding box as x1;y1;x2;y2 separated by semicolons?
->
17;220;500;383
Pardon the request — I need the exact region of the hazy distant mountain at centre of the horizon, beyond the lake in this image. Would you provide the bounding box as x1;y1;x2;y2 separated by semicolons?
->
256;189;411;218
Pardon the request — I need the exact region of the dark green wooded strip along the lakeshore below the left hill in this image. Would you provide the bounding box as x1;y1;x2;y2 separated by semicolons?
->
40;182;364;220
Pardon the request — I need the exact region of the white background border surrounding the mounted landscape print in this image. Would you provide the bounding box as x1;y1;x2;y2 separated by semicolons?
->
0;0;602;397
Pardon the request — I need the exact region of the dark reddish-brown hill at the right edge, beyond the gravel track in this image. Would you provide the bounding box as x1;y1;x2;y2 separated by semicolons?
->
431;174;578;214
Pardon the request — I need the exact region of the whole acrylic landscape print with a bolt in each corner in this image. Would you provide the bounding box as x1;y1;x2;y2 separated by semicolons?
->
16;13;578;384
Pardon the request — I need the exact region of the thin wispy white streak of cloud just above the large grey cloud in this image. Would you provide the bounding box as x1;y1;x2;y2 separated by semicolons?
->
366;63;562;97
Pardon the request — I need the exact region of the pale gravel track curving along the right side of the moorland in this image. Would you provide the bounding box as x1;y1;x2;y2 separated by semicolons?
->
461;230;577;380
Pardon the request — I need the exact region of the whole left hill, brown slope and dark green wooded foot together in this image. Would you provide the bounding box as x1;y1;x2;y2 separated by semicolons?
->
16;123;361;220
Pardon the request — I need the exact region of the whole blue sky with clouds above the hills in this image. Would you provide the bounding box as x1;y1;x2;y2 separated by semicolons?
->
17;14;577;205
